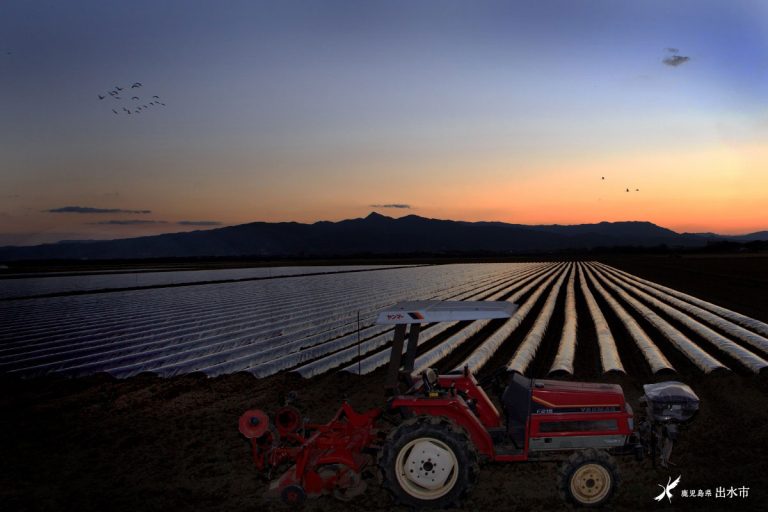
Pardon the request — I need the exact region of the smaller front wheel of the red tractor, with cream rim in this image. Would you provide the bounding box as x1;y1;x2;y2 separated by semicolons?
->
560;448;619;507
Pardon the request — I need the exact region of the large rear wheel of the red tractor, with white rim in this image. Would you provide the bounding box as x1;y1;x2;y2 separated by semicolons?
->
379;416;479;508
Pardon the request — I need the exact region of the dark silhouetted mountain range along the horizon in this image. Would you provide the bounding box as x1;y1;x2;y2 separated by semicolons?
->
0;213;768;261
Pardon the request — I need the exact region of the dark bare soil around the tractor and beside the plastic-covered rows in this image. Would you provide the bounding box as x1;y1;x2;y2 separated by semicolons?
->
0;257;768;511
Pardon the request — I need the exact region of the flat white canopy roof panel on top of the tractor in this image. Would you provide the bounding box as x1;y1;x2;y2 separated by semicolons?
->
376;300;517;325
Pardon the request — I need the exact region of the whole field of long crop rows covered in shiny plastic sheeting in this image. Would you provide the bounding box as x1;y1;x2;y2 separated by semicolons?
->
0;262;768;377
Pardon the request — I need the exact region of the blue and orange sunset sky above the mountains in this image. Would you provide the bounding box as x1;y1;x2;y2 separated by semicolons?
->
0;0;768;245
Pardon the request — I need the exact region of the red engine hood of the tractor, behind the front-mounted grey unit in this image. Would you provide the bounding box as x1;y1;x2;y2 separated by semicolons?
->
531;380;625;412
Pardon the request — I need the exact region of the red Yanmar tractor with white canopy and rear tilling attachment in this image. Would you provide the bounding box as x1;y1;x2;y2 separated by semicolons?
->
240;301;699;508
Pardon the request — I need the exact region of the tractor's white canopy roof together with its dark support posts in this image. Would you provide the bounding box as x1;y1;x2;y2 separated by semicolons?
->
376;300;517;395
